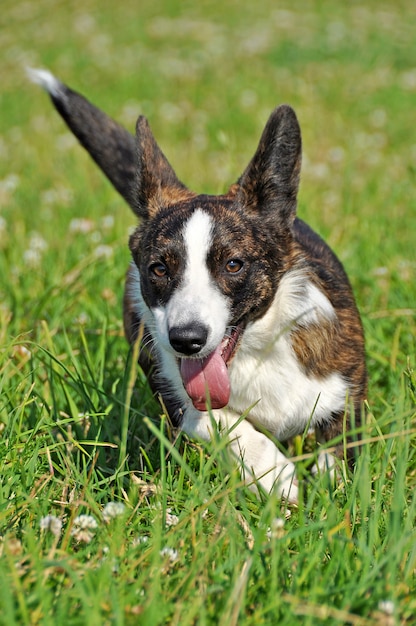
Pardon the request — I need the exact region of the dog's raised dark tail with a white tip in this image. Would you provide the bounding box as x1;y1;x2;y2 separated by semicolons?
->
28;69;137;206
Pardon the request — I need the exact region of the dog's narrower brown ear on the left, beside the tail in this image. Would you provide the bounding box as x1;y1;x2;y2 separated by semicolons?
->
133;116;195;218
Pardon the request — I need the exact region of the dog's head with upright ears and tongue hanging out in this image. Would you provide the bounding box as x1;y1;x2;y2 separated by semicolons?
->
130;106;301;410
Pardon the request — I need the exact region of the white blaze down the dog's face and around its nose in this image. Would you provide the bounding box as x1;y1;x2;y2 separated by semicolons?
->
154;209;230;356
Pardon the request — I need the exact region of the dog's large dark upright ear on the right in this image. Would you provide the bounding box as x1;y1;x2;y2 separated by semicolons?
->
236;105;302;226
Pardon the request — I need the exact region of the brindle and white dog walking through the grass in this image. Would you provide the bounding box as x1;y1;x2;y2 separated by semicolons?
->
31;70;367;503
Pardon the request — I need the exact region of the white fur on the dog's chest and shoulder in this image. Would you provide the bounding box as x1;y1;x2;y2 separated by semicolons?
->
230;271;347;440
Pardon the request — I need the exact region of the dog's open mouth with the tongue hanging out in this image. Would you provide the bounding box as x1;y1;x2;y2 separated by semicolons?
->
180;324;243;411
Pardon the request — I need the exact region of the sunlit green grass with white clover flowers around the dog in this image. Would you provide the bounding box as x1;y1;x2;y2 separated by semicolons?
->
0;0;416;626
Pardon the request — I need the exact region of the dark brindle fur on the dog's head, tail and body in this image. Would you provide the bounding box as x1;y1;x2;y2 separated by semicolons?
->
36;74;367;472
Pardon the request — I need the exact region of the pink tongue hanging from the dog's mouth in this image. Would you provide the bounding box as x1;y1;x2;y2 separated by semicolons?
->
181;348;230;411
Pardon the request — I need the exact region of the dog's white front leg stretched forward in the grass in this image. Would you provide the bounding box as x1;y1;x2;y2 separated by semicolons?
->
182;409;298;504
